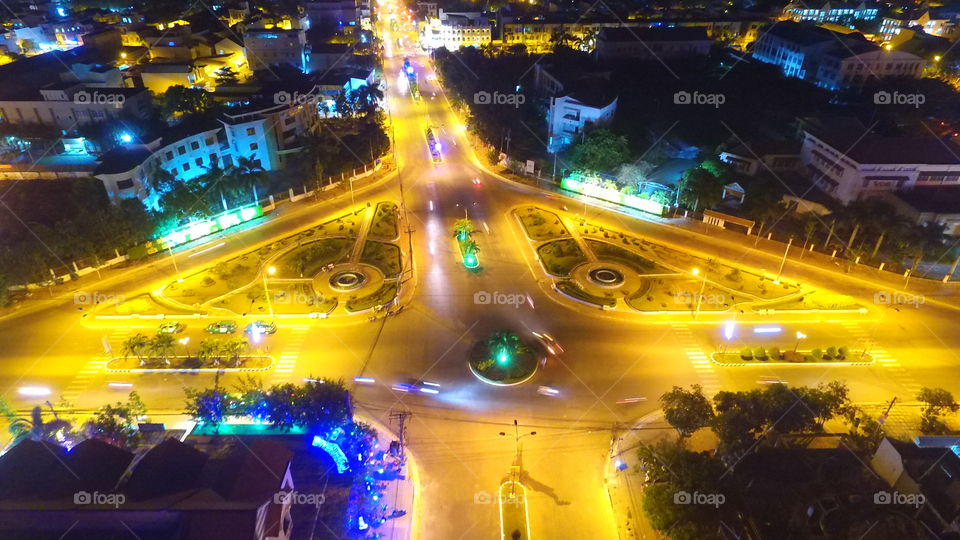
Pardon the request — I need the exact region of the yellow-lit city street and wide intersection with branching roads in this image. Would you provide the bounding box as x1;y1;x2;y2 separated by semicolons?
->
0;5;960;539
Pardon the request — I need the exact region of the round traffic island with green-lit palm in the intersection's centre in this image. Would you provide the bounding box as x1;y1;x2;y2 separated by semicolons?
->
467;330;541;386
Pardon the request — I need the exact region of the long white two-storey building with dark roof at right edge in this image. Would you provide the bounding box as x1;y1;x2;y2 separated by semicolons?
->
800;118;960;203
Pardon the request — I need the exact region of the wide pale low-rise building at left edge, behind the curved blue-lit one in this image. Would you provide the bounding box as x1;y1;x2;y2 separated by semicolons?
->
0;82;151;129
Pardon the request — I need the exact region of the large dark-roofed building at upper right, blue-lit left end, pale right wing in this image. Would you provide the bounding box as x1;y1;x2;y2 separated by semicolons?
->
752;21;925;90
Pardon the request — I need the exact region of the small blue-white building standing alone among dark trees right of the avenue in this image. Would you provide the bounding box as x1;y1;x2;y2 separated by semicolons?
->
534;64;617;153
